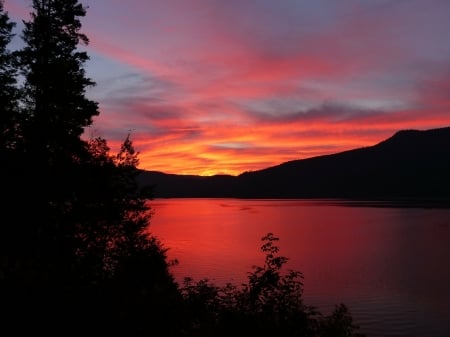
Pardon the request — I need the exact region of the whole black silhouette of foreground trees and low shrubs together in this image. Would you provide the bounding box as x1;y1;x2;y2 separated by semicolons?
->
0;0;364;336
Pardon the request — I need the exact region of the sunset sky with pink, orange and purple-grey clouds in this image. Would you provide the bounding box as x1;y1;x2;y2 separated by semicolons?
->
5;0;450;175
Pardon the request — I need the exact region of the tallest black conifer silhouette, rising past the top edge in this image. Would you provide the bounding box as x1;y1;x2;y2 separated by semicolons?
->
8;0;99;282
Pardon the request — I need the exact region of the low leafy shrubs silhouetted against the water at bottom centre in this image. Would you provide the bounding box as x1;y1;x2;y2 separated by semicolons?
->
181;233;363;337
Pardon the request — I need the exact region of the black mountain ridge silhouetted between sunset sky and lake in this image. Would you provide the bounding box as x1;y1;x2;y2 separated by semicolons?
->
138;127;450;200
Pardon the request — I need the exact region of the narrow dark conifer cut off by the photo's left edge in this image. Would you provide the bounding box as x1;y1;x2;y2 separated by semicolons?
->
0;0;27;300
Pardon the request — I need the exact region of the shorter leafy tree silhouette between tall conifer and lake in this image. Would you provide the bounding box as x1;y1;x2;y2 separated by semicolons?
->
69;135;182;336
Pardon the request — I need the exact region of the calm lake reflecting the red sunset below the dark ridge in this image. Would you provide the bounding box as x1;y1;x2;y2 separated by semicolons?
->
150;199;450;337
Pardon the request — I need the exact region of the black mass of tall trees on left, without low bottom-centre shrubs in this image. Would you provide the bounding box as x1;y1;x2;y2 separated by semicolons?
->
0;0;181;336
